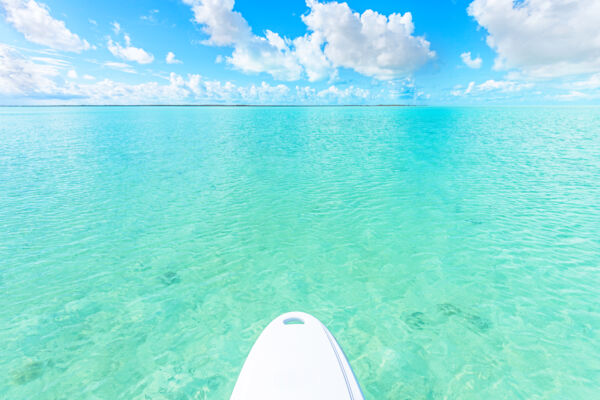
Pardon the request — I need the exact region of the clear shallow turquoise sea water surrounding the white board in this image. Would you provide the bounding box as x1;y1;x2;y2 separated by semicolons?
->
0;107;600;399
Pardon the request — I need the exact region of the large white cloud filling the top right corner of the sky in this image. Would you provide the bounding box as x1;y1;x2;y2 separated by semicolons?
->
468;0;600;77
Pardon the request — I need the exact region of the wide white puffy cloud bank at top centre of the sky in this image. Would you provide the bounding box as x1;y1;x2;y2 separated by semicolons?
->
183;0;435;81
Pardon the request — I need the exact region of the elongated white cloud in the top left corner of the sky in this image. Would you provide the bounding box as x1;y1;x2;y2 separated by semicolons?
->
0;0;90;53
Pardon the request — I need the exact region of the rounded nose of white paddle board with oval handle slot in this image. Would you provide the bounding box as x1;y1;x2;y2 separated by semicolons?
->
231;312;363;400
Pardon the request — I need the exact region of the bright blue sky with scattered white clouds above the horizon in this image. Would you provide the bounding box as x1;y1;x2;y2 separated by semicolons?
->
0;0;600;105
